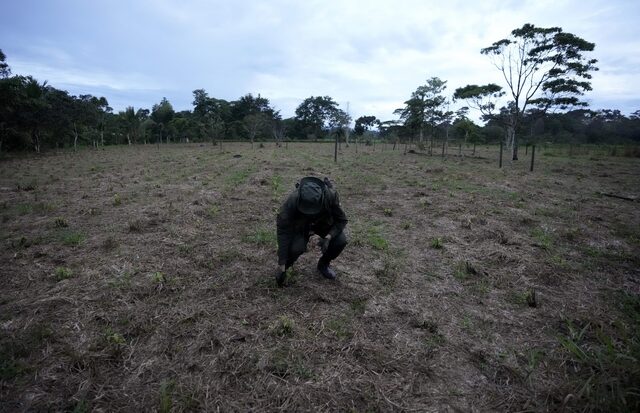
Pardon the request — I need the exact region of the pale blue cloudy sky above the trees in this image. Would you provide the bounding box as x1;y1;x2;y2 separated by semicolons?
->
0;0;640;120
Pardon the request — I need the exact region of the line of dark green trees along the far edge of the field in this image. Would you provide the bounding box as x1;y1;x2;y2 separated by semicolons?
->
0;24;640;156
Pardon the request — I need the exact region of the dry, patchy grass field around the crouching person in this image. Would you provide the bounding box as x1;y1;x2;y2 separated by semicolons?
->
0;143;640;412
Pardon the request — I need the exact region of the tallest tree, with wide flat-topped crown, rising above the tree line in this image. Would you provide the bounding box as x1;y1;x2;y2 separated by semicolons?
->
480;23;598;160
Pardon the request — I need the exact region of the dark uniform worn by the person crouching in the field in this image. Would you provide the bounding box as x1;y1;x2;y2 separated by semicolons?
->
276;180;348;268
